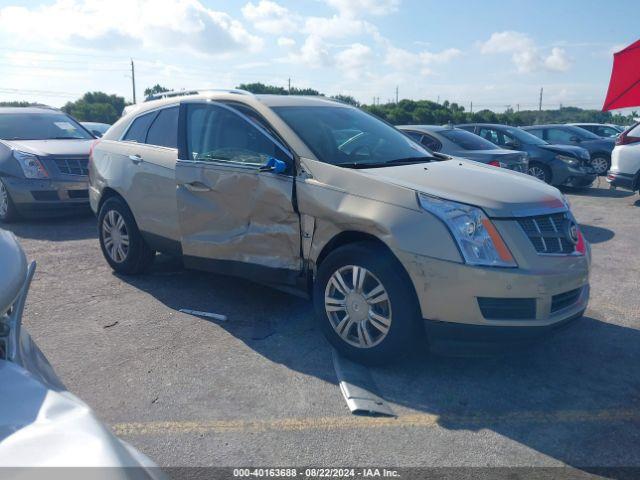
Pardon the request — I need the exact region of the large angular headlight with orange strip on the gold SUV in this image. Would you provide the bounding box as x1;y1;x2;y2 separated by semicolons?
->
418;193;518;267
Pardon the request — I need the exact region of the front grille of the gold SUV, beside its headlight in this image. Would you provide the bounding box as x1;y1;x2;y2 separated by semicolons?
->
518;213;575;254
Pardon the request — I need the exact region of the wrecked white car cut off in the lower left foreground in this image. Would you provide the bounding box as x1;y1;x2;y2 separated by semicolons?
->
0;229;165;479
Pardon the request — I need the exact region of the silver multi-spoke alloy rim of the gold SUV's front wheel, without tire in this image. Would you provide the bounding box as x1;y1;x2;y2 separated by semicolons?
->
324;265;392;348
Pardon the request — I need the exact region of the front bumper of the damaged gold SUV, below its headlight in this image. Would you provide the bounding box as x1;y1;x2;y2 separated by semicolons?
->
398;252;589;344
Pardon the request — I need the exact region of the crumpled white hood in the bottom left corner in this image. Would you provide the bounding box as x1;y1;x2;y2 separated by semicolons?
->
0;360;165;472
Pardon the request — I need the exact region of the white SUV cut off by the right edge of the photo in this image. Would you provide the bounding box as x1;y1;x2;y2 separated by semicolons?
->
607;123;640;191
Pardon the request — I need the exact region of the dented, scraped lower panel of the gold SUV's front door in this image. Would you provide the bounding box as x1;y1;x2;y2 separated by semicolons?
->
176;161;301;270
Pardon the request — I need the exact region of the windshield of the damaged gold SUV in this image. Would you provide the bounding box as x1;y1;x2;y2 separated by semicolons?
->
273;107;433;167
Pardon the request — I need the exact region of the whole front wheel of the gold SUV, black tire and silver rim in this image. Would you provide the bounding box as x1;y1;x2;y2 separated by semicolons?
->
313;242;420;365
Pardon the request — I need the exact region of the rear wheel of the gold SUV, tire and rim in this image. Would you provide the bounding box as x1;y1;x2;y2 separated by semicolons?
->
98;197;156;275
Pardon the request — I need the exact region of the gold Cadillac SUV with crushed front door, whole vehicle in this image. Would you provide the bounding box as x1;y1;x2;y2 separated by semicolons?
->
89;91;590;363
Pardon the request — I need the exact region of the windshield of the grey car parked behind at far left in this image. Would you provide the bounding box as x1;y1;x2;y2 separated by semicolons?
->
0;112;93;140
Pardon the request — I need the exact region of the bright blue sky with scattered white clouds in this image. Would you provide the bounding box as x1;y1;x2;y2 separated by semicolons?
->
0;0;640;110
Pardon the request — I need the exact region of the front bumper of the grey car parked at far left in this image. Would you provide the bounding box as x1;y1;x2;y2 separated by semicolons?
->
4;177;89;216
